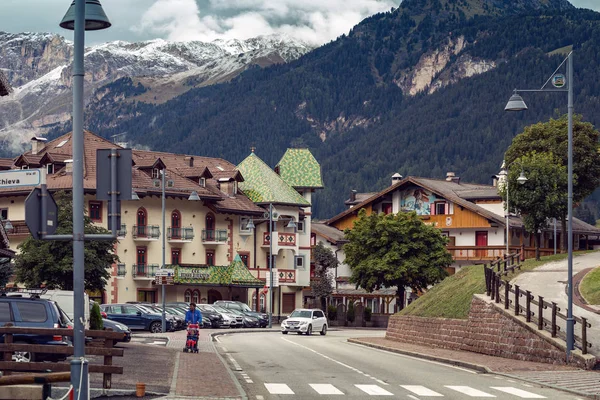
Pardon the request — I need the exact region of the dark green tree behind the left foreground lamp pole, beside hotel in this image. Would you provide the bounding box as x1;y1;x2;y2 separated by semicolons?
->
15;192;118;290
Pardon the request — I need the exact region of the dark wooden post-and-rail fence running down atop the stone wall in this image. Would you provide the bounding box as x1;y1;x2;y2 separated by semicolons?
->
484;253;592;354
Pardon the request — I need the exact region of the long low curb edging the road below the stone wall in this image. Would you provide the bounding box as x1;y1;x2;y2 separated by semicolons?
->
348;339;600;400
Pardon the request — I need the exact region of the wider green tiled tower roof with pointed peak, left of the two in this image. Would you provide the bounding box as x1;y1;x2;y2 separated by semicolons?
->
237;153;310;207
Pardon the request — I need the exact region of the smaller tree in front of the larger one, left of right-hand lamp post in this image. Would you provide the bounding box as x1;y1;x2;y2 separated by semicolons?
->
501;152;567;260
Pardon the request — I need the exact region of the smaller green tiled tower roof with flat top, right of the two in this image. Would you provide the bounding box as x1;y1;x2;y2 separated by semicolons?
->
275;149;323;188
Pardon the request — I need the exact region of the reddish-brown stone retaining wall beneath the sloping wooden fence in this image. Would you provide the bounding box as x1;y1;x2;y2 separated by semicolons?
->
386;295;596;369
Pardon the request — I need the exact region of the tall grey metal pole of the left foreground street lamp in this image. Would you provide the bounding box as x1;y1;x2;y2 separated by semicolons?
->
71;0;89;400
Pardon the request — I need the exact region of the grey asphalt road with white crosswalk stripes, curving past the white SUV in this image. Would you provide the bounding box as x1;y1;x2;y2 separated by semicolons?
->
217;330;580;400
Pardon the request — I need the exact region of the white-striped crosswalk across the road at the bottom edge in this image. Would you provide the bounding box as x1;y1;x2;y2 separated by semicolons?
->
264;383;546;399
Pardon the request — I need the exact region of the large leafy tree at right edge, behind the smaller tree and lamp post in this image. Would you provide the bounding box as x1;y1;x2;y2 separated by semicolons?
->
505;115;600;249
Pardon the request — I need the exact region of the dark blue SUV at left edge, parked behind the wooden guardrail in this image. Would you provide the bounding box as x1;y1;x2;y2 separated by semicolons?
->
0;293;72;362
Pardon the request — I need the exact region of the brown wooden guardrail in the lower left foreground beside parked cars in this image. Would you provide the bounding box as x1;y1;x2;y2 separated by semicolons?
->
0;326;123;389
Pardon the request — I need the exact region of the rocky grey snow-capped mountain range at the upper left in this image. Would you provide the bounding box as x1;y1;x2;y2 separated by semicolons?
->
0;32;311;150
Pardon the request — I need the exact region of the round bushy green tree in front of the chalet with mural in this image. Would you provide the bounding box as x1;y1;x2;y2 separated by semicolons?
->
344;209;452;307
